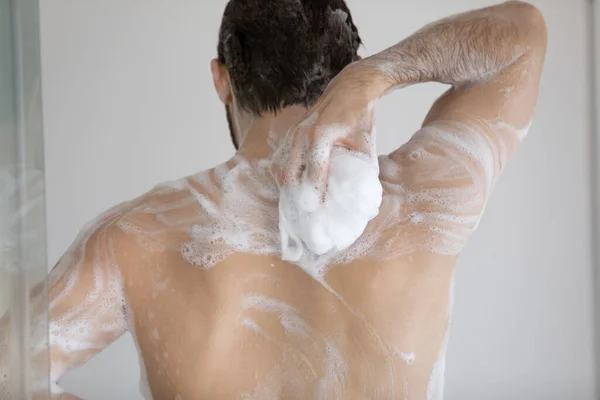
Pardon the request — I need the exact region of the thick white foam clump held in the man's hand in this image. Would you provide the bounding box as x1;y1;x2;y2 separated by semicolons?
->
279;147;383;262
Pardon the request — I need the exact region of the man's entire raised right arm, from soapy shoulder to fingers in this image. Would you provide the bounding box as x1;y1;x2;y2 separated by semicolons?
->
274;1;547;255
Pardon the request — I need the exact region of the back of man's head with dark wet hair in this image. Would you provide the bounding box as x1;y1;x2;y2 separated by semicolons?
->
218;0;361;115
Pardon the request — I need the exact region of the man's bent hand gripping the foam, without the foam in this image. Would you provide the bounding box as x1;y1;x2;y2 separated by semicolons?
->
273;61;379;201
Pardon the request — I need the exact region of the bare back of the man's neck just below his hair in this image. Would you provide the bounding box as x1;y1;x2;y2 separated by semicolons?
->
236;106;307;158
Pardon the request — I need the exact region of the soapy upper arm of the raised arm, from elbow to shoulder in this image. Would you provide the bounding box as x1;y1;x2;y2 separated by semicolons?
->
389;10;546;254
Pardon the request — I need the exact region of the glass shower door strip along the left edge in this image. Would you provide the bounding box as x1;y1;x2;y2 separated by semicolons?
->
0;0;49;400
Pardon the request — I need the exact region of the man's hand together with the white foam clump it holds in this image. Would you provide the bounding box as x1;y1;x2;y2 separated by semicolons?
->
273;64;382;260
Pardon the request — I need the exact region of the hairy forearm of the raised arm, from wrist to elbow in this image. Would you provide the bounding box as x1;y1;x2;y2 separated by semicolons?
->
364;1;546;91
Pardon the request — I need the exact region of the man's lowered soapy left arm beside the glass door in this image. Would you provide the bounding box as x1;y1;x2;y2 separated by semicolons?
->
0;208;127;400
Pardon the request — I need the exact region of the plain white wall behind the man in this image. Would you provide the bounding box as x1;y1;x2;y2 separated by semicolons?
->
41;0;595;400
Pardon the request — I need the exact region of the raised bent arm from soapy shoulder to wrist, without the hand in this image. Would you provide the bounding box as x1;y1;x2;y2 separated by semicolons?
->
367;1;547;250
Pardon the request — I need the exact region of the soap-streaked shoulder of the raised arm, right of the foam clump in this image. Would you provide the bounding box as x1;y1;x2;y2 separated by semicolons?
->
379;122;502;255
